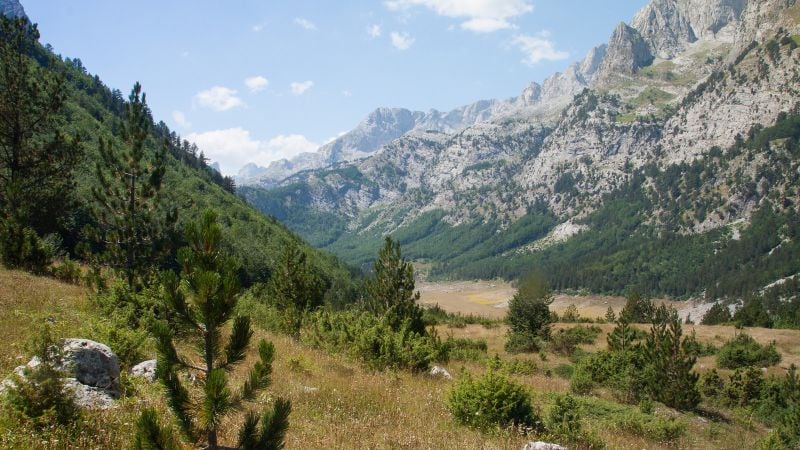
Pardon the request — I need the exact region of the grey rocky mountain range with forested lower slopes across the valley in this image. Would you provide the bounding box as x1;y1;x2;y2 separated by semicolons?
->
240;0;800;302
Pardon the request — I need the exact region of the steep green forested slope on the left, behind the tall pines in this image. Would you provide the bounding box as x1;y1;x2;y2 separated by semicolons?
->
14;14;350;284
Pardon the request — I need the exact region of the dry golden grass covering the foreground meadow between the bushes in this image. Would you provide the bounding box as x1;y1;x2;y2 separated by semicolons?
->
0;270;800;449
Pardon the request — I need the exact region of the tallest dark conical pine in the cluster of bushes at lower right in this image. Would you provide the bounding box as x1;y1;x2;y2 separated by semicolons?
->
645;305;700;410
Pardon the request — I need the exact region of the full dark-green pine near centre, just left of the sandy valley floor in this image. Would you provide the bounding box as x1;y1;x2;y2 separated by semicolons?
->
267;241;325;337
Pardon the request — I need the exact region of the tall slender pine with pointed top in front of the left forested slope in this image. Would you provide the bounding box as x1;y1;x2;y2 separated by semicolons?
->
92;83;177;290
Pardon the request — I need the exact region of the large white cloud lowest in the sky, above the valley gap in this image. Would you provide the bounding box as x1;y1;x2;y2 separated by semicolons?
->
186;127;319;175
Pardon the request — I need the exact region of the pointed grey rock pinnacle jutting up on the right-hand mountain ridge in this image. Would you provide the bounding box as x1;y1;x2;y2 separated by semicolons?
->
600;23;653;77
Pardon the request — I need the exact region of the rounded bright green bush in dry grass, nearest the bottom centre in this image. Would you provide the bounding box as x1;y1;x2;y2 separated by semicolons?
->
447;369;543;431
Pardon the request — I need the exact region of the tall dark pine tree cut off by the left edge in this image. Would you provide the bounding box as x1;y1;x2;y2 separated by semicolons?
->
0;17;82;271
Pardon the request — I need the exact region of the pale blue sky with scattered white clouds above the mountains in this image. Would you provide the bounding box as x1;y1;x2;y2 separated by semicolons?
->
21;0;647;175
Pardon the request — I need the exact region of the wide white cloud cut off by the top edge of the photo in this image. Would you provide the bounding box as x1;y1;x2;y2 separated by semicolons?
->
385;0;533;33
